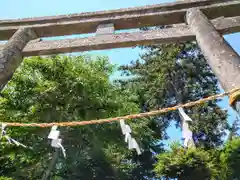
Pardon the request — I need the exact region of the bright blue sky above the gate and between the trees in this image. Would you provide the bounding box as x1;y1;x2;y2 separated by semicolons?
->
0;0;240;146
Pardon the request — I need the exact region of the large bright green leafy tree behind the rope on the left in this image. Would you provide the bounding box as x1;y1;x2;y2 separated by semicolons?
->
0;56;160;180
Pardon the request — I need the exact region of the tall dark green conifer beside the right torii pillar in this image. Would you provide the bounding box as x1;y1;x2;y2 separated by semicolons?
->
121;42;228;149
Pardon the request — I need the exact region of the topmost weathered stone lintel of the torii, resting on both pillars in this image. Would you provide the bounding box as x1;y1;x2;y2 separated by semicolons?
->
0;0;240;40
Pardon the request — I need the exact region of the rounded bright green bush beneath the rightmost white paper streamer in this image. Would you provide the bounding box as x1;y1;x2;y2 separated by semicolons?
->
155;144;220;180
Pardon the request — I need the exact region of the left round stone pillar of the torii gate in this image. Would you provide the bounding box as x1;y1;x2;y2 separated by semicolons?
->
0;27;37;91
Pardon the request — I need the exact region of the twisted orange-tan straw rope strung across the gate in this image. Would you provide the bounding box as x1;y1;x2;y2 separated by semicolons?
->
2;88;240;128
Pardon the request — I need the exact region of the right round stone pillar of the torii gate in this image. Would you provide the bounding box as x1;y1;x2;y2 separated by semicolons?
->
186;8;240;112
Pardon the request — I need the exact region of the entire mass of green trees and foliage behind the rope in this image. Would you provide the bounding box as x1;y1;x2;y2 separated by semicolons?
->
0;42;240;180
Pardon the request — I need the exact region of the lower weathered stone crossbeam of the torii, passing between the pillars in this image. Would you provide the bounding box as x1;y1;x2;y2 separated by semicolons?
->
0;16;240;56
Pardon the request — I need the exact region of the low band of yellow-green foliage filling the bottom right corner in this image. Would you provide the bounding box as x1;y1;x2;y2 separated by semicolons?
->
155;137;240;180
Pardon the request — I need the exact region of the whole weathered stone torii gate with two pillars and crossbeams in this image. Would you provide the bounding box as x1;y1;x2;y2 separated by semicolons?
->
0;0;240;108
